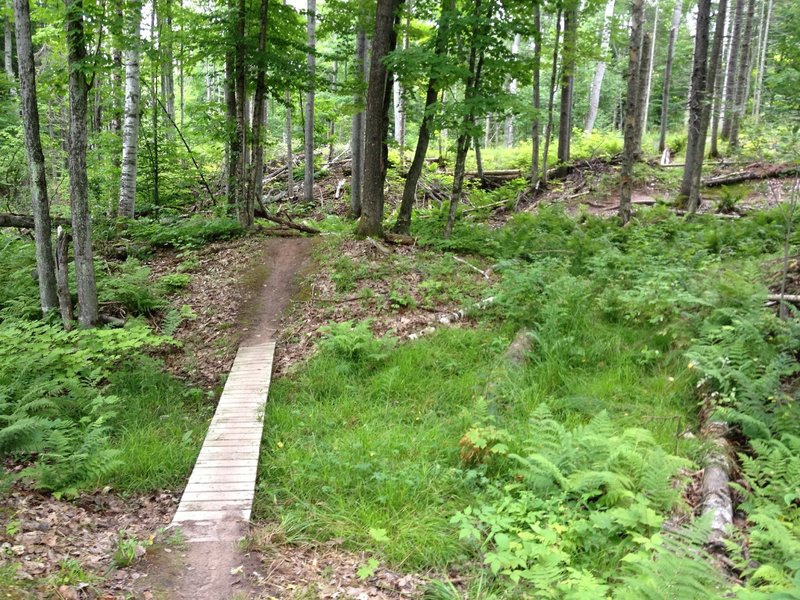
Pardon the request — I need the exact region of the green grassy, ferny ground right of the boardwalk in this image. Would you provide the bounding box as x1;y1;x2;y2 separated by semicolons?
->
256;204;797;598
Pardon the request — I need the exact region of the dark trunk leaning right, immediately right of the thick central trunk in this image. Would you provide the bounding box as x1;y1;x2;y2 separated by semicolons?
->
393;0;456;234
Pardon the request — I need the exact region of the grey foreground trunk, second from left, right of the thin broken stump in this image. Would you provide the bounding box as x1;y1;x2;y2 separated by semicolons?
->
64;0;98;327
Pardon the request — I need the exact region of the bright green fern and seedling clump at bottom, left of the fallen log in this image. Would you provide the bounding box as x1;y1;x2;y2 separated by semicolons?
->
453;404;698;598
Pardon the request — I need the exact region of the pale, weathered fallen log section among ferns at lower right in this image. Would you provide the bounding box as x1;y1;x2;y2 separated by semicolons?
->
702;421;733;552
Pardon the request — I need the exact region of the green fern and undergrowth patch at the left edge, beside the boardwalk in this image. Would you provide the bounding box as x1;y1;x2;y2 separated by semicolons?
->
0;320;174;494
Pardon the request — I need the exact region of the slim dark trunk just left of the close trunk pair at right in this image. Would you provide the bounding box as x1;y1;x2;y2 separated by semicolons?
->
619;0;648;225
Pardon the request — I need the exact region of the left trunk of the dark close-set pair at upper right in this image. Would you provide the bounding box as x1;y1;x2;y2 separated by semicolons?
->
680;0;713;201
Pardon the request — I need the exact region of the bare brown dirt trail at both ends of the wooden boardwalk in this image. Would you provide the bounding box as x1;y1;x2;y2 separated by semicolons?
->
145;238;313;600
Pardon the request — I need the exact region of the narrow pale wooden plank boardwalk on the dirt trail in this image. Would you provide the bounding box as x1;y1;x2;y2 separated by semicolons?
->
172;342;275;542
